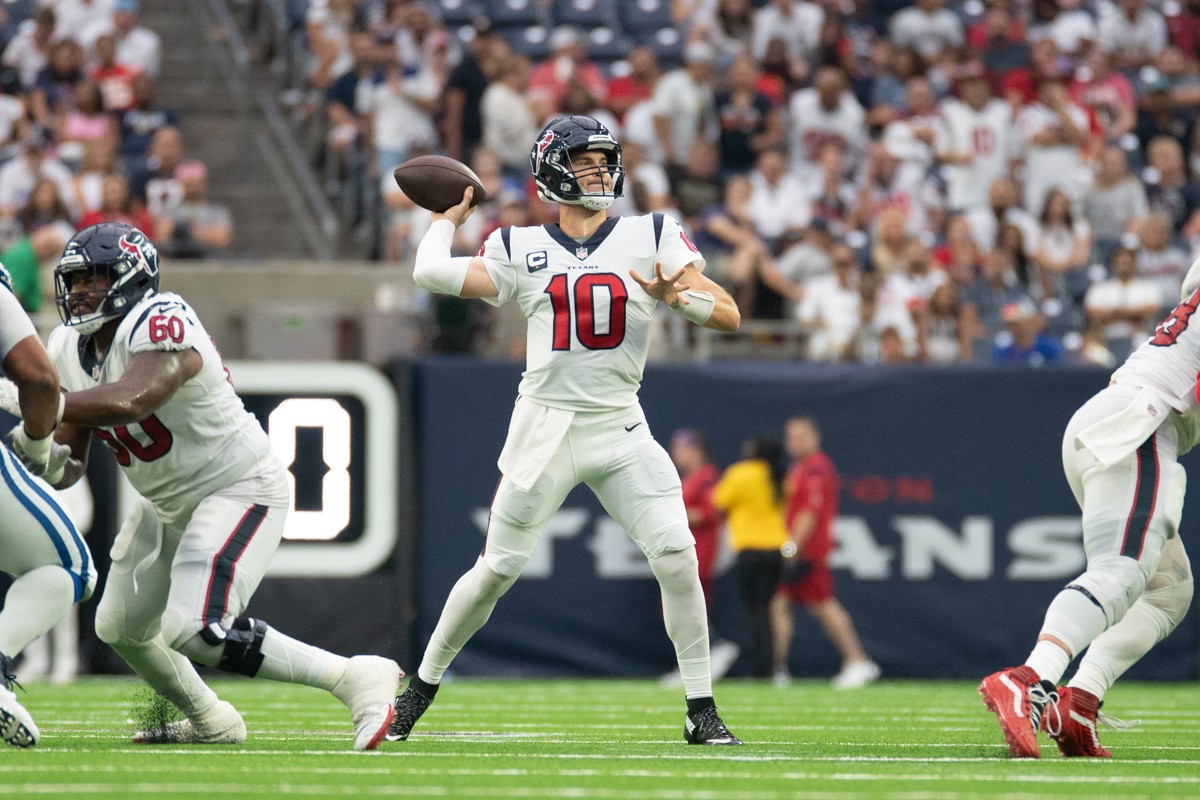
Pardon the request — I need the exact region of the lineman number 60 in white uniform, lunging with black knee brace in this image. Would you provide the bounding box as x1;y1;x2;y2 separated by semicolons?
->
3;222;403;750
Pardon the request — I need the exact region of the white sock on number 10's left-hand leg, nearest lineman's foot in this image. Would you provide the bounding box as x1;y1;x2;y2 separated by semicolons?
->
416;559;517;684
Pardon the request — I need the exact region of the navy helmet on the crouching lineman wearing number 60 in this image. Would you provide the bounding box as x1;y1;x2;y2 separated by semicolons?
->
54;222;158;335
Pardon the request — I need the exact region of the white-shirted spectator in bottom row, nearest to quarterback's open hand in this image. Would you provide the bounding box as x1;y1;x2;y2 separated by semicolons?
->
797;245;860;361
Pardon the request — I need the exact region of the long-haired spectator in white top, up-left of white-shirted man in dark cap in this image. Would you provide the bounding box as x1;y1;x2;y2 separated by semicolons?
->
1033;188;1092;303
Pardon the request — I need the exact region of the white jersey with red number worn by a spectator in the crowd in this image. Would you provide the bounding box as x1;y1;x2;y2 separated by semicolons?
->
937;100;1014;210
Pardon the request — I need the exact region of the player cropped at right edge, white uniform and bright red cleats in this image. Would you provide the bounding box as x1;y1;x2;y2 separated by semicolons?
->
979;260;1200;758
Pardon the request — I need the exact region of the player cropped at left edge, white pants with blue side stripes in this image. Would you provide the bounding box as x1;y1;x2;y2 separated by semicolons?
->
0;266;96;747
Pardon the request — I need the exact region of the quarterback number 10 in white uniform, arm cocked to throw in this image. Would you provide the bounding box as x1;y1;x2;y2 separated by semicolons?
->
388;116;742;745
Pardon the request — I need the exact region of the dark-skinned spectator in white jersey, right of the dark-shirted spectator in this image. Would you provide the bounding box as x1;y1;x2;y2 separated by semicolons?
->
787;67;866;174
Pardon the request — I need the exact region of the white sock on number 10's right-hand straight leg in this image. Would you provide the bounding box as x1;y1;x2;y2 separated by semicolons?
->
650;548;713;698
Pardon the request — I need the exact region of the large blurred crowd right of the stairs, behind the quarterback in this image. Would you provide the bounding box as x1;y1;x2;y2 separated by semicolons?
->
289;0;1200;366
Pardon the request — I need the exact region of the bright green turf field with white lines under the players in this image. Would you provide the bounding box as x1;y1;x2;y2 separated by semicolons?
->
0;679;1200;800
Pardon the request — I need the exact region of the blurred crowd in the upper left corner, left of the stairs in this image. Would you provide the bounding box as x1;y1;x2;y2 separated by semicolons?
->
0;0;233;312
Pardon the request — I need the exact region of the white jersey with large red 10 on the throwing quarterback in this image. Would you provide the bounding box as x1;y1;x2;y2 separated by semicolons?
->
480;213;704;411
